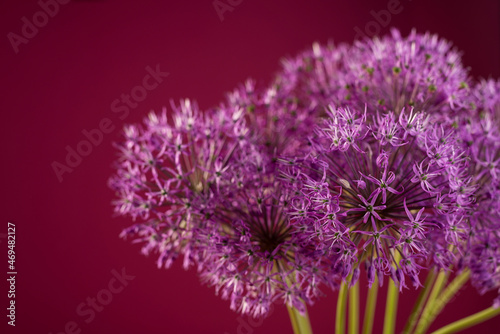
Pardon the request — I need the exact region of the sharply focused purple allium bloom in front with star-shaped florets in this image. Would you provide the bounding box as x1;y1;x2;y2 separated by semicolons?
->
281;108;475;288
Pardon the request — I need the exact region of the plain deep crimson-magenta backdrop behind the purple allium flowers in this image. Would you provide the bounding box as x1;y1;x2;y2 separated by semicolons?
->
0;0;500;334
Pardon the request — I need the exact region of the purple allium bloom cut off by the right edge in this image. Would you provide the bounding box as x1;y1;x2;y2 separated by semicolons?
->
452;80;500;306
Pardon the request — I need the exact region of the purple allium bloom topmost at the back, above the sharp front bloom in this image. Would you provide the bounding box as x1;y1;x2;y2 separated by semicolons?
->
281;29;470;114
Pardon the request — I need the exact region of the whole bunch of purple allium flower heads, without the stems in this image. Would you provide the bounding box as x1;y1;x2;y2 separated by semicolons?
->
110;30;500;317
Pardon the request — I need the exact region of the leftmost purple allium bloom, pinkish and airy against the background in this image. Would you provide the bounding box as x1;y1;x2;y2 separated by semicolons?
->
110;100;249;267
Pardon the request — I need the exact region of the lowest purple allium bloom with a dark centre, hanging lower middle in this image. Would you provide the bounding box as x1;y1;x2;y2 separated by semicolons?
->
194;167;338;317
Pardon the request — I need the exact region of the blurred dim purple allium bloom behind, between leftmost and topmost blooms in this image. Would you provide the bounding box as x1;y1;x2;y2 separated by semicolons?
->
226;43;347;157
